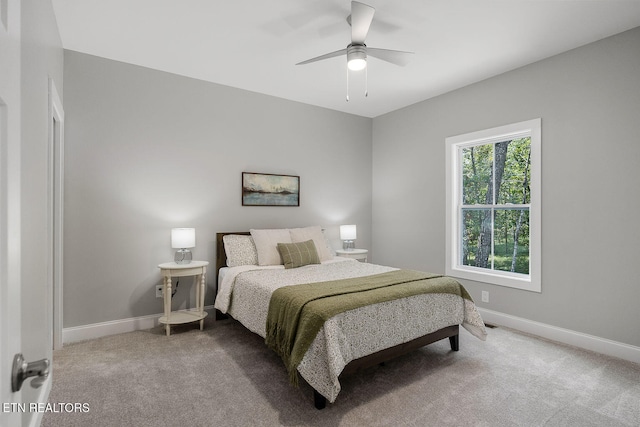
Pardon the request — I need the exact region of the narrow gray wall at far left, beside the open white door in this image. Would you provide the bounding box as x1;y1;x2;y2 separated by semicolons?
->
20;1;63;418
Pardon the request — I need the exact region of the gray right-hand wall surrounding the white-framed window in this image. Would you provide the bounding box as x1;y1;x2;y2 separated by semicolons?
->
373;28;640;346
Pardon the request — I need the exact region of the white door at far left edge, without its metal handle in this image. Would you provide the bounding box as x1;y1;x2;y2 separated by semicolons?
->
0;0;24;427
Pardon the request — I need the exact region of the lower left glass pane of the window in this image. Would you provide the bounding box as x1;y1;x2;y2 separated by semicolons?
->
460;209;492;268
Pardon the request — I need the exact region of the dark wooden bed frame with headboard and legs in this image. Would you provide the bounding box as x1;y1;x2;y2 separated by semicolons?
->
216;231;459;409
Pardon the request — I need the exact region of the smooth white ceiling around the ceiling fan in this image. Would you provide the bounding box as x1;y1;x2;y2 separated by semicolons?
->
53;0;640;117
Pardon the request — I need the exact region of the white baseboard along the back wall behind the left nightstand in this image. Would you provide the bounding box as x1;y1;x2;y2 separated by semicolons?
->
62;305;213;344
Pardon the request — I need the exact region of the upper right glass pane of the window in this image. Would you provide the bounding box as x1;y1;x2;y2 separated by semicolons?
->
496;137;531;204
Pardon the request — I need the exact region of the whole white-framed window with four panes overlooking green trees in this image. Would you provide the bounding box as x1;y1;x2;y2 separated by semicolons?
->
446;119;541;292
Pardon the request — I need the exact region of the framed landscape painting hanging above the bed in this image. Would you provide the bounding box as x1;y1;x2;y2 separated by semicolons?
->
242;172;300;206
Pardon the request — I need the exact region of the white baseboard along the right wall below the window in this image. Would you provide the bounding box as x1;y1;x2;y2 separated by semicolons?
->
478;307;640;363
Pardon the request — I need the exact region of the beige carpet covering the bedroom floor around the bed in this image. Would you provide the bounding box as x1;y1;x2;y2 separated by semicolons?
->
43;316;640;427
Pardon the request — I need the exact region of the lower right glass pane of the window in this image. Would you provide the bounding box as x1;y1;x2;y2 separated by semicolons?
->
494;209;529;274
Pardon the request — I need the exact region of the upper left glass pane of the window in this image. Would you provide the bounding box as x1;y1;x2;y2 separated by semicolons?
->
462;144;493;205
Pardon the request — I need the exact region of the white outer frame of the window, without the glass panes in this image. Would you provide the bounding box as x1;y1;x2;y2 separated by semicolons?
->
445;119;542;292
